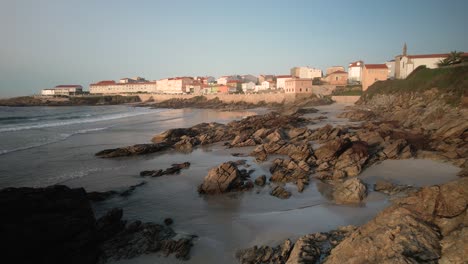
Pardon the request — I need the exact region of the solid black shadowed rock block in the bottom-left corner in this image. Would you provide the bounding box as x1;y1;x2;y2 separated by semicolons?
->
0;185;99;264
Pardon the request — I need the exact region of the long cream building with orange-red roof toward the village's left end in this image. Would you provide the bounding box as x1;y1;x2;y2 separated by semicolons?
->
89;78;157;94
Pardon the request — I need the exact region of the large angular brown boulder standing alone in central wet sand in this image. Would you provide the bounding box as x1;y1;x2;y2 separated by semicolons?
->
198;162;251;194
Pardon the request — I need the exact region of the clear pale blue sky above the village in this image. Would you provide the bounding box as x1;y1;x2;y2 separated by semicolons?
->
0;0;468;97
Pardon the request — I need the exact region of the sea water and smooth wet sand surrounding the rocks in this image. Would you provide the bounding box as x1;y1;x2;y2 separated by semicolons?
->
0;105;458;264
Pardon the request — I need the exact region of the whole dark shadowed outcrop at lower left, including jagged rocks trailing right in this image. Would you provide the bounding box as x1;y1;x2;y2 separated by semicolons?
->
0;185;193;264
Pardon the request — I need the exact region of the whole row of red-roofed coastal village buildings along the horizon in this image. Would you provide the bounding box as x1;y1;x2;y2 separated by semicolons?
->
41;44;468;96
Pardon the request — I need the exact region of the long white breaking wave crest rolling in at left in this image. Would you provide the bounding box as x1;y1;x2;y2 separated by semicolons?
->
0;111;160;133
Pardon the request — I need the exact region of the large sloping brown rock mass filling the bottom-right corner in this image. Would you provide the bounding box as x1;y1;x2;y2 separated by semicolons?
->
326;178;468;263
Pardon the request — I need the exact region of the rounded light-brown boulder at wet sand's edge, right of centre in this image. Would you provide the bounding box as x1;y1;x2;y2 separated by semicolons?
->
333;178;367;204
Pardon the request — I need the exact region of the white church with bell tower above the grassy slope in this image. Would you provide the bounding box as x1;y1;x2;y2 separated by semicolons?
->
395;43;468;79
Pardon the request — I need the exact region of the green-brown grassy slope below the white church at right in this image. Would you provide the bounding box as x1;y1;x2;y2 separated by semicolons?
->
361;66;468;106
